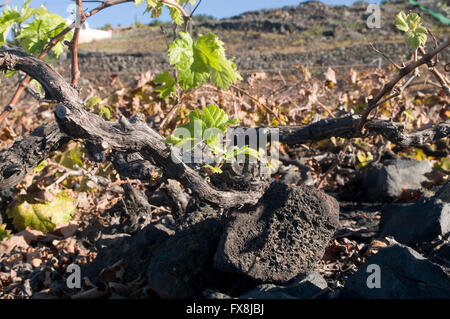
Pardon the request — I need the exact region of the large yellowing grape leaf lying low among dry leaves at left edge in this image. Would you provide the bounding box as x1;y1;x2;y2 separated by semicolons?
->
6;192;75;232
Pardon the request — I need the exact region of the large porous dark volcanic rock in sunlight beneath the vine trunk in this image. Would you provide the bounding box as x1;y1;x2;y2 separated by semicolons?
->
214;182;339;283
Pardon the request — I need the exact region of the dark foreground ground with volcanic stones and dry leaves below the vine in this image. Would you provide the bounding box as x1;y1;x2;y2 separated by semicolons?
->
0;159;450;299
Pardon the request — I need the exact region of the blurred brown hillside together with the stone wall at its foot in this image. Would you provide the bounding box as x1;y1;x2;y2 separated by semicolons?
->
50;1;450;84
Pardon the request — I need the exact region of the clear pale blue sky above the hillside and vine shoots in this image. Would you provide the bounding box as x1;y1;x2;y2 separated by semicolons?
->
0;0;379;28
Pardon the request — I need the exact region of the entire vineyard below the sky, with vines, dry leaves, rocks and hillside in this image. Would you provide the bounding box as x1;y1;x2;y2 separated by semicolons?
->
0;0;450;299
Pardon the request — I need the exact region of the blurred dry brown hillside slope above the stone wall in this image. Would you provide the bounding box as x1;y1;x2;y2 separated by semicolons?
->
82;1;450;55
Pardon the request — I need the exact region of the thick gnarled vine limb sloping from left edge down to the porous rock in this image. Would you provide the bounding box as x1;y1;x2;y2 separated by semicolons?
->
0;50;264;208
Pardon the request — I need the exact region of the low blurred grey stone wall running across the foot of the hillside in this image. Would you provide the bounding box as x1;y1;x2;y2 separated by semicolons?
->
58;43;450;81
